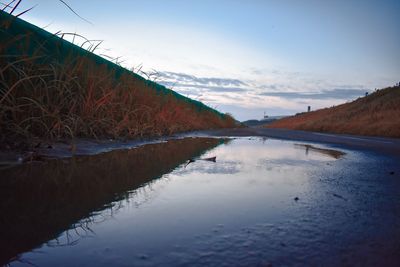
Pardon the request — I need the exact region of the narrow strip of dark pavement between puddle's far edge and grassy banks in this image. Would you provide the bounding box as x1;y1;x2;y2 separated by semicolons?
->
0;127;400;166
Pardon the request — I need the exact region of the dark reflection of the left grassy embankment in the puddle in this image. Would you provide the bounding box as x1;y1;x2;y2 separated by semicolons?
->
0;138;224;265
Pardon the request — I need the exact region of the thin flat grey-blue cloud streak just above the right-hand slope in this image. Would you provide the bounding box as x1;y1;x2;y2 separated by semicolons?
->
260;87;368;99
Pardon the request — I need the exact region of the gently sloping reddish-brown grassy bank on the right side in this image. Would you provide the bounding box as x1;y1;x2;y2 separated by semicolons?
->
266;86;400;138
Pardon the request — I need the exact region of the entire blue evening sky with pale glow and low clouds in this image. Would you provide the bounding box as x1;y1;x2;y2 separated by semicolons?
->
0;0;400;121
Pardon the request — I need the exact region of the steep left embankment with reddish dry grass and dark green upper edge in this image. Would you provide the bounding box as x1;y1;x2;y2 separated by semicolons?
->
0;11;235;150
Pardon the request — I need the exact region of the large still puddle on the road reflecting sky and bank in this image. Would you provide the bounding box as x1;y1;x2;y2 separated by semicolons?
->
0;138;400;266
